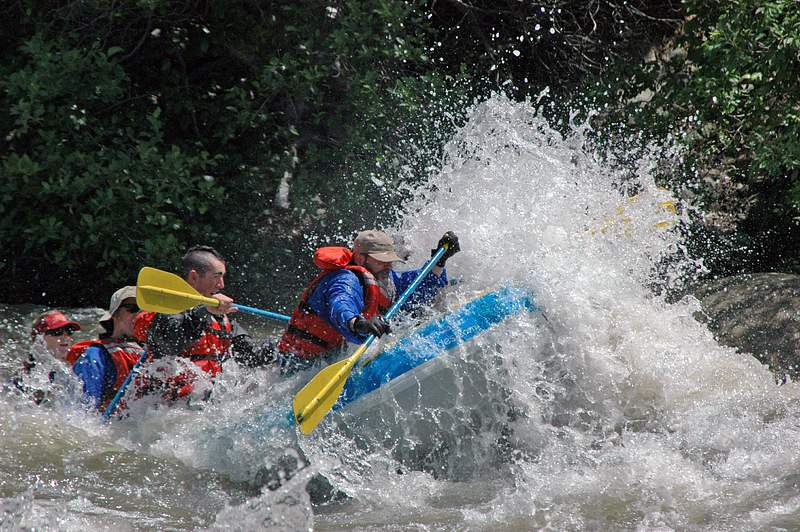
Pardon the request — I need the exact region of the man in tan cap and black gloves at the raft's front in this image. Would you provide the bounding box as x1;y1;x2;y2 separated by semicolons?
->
278;230;460;373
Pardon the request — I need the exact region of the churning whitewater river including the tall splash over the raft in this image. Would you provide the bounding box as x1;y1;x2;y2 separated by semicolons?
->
0;97;800;531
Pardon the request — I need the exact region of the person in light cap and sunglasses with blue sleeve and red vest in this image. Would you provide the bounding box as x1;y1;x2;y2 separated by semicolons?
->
67;286;144;410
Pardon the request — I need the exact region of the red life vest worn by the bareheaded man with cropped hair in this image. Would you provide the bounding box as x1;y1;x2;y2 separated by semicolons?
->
134;312;233;377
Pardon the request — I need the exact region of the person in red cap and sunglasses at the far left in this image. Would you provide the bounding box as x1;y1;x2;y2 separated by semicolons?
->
7;310;81;405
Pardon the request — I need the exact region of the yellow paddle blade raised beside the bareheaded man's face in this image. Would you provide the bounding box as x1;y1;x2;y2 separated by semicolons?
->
136;266;219;314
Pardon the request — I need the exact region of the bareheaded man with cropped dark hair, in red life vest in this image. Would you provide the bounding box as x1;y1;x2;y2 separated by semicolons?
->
136;246;272;395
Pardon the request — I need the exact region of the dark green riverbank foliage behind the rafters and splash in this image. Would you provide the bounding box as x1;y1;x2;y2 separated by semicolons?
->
6;0;800;303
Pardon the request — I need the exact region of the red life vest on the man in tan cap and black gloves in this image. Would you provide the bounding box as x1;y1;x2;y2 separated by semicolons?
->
278;246;392;360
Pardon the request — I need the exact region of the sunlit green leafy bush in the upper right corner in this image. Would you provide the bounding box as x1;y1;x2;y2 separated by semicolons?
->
680;0;800;183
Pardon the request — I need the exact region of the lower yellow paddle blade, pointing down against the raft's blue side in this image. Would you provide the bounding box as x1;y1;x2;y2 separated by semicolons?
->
292;344;369;434
